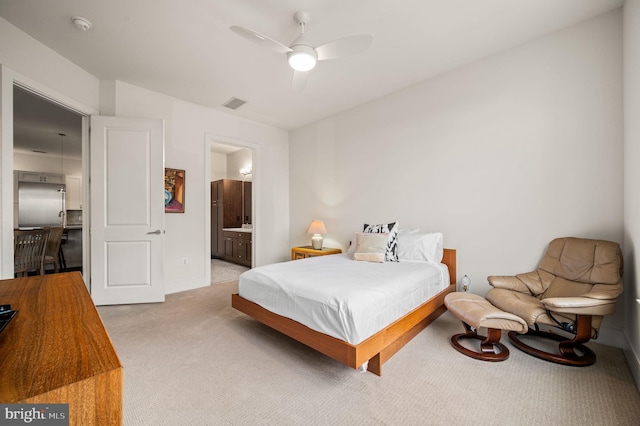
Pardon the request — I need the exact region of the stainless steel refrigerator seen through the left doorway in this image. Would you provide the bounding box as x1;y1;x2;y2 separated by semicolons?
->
18;182;66;228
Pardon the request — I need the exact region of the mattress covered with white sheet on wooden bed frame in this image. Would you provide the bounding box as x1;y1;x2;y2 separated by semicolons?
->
238;254;449;345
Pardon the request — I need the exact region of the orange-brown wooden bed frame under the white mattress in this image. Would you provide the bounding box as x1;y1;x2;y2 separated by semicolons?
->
231;249;456;376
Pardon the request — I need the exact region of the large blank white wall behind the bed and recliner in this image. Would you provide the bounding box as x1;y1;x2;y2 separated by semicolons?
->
290;10;624;342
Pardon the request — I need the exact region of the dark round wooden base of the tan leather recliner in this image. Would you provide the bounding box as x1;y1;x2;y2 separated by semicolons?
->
508;329;596;367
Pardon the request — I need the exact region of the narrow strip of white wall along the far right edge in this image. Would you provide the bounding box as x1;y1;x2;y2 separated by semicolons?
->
624;0;640;388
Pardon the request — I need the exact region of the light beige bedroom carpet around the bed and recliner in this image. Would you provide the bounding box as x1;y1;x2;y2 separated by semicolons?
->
99;281;640;426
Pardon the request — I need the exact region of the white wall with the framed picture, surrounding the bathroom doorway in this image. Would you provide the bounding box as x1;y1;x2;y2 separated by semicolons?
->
115;81;290;293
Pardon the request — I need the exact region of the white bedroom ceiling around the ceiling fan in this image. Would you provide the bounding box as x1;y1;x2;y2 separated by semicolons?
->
0;0;623;129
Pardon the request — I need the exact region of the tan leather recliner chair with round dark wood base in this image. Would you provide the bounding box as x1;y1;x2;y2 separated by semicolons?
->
486;237;623;366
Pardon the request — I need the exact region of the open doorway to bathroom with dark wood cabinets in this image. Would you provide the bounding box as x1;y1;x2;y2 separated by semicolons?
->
209;141;255;284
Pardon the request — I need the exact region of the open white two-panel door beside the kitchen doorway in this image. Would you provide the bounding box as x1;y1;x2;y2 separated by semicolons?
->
89;116;164;305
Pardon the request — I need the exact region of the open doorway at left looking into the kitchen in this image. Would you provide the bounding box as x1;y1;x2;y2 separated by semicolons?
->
13;85;83;273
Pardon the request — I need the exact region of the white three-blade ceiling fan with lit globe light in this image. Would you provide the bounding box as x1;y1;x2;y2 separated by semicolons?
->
229;12;373;91
